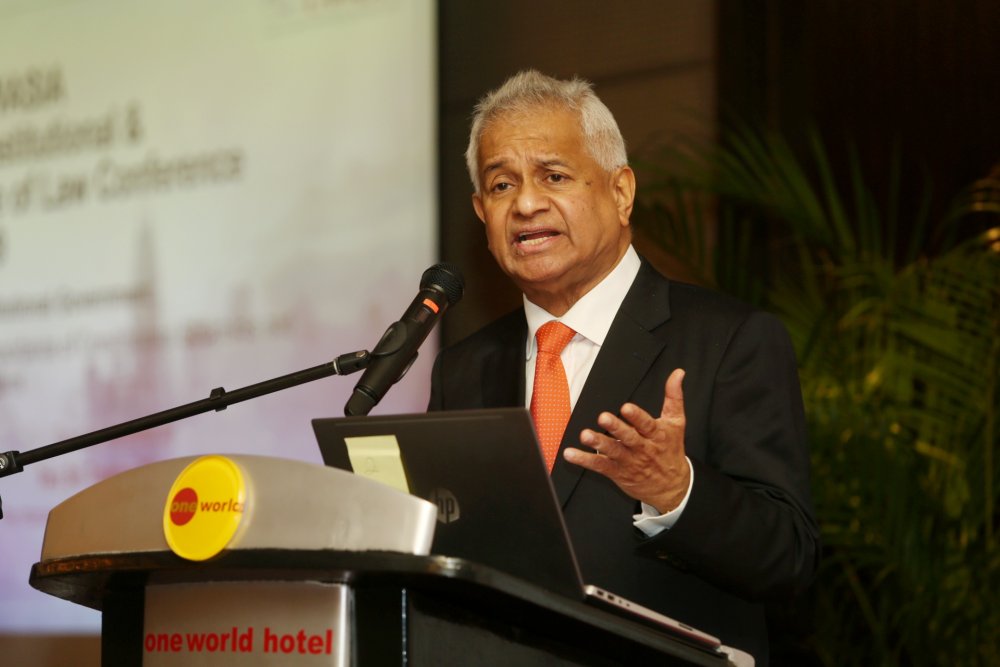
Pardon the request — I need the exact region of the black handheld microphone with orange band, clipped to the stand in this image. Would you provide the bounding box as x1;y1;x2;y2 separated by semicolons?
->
344;263;465;416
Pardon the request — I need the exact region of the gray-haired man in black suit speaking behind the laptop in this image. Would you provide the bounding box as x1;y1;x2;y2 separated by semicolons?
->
430;71;819;664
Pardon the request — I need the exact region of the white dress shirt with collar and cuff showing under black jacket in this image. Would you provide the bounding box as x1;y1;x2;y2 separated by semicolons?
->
524;246;694;537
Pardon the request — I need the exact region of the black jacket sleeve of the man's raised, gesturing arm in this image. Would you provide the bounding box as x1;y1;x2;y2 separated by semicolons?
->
638;312;819;599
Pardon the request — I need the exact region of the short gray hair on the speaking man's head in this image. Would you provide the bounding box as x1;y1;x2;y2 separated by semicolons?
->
465;69;628;194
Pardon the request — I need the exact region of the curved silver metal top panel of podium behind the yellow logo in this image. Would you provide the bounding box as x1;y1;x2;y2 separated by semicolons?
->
41;455;437;563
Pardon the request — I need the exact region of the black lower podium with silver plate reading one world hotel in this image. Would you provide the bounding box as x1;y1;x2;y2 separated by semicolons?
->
30;549;728;667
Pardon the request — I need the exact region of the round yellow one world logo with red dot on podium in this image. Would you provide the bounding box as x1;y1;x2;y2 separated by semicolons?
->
163;455;246;560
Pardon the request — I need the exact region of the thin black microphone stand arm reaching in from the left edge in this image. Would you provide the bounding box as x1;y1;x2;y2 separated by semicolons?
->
0;350;372;519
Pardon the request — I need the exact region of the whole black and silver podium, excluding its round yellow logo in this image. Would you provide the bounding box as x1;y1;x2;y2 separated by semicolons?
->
30;456;727;667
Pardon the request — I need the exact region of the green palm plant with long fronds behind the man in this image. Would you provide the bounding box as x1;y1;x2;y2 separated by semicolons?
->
636;127;1000;665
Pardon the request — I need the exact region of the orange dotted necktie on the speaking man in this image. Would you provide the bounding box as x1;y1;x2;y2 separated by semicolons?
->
531;320;576;472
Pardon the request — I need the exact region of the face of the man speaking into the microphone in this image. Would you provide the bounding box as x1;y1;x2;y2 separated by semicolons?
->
472;107;635;316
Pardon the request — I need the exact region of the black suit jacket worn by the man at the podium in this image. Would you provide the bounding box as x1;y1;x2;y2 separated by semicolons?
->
430;261;819;665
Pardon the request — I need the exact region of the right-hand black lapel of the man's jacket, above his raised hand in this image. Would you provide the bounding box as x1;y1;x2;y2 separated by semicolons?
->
548;260;670;507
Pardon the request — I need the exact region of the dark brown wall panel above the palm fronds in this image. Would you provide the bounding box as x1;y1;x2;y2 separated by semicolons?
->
718;0;1000;253
